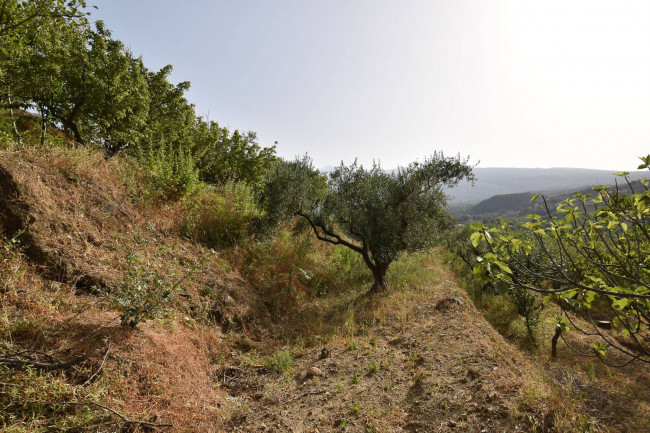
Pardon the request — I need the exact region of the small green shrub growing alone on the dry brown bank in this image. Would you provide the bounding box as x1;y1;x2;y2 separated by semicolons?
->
115;255;178;328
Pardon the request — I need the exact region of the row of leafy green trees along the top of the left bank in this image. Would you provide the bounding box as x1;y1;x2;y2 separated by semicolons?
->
0;0;276;199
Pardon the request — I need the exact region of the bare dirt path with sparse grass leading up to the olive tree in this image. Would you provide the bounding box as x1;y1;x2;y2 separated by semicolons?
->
219;280;544;432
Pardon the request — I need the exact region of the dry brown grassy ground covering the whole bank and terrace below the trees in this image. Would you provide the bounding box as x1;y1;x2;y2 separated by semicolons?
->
0;144;650;432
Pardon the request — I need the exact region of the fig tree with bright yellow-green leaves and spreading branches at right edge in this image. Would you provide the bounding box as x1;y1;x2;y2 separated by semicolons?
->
471;156;650;366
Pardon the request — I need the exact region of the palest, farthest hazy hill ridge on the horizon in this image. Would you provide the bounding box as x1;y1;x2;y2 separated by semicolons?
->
448;168;648;204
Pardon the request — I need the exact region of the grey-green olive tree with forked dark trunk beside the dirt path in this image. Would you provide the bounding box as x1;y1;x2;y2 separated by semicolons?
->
265;152;474;292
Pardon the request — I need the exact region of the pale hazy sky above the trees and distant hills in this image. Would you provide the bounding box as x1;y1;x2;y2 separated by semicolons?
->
89;0;650;170
